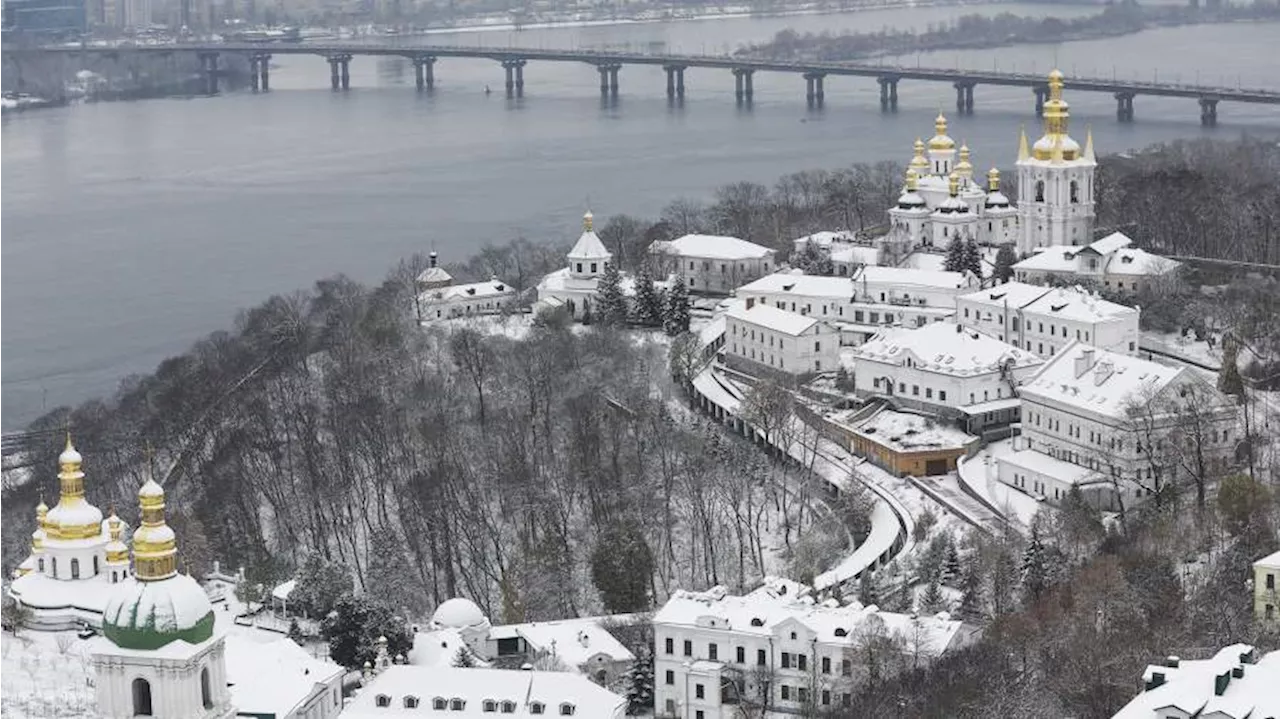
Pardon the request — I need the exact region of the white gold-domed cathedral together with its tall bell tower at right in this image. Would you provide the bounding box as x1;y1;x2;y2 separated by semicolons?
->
886;70;1097;255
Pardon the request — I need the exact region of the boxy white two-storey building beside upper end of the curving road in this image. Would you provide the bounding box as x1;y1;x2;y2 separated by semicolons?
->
724;299;840;375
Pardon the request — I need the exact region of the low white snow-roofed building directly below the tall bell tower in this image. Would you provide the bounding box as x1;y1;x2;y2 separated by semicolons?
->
1014;232;1181;292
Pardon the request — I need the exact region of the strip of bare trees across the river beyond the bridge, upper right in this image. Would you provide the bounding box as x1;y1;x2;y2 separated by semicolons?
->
739;0;1280;60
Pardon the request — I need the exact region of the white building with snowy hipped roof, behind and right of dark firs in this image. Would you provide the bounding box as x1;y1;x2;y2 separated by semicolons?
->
649;234;778;294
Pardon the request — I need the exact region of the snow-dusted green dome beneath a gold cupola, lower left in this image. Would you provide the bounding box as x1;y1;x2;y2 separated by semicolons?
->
102;574;214;650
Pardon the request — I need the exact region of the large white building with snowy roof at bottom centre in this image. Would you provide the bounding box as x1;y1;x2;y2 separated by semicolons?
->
653;580;972;719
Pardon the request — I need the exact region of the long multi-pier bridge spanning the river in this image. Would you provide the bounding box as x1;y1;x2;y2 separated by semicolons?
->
20;42;1280;127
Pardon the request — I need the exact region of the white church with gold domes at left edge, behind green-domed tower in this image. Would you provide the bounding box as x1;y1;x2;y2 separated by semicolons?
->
9;436;131;629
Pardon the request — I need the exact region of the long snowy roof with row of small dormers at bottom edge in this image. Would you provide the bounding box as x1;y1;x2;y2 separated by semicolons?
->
342;665;626;719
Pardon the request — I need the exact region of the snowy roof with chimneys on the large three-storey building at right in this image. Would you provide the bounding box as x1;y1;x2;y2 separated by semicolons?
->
1020;342;1187;420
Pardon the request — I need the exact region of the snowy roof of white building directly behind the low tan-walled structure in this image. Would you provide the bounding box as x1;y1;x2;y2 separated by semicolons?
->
851;322;1043;376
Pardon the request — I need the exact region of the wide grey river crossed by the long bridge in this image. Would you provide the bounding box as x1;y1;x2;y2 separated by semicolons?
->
0;5;1280;429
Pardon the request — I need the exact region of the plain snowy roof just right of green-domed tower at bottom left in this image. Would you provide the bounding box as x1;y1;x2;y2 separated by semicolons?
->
225;633;344;716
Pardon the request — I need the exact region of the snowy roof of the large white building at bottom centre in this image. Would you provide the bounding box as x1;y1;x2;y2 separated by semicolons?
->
653;587;961;656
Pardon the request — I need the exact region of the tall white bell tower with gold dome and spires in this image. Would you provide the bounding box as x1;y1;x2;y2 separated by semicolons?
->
1018;70;1098;253
